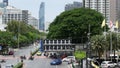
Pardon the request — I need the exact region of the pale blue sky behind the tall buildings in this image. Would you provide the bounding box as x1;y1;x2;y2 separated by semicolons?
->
7;0;82;22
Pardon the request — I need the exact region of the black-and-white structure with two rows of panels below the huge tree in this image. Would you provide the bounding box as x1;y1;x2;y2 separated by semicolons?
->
43;40;75;53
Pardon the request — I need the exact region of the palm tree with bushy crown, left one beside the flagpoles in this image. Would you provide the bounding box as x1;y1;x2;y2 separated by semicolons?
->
91;35;108;58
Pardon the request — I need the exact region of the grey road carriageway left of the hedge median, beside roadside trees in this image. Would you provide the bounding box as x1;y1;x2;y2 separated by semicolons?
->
0;45;36;68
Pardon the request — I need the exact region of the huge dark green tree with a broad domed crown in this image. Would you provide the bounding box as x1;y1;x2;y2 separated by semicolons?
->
47;8;104;40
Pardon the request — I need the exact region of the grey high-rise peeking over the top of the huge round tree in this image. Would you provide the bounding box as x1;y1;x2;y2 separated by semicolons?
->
65;2;82;11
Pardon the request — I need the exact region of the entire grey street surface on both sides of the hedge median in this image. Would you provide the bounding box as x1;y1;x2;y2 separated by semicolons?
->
0;45;70;68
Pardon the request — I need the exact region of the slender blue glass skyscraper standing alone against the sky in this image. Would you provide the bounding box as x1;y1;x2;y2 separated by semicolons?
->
39;2;45;31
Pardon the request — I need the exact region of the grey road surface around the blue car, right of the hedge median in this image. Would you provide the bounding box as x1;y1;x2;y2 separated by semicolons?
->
24;58;70;68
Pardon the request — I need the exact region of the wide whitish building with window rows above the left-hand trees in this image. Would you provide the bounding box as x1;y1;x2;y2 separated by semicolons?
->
1;6;28;24
